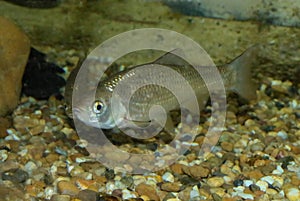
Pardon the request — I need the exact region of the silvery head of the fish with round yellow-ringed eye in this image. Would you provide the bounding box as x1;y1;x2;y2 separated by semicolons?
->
73;87;126;129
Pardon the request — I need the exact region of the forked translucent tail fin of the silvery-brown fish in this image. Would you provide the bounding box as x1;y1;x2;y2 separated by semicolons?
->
229;45;258;100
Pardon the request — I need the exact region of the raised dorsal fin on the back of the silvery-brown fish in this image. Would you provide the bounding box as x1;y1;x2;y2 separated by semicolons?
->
153;49;187;66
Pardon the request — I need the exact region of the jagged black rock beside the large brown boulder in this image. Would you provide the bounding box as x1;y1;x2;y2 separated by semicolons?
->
22;48;66;99
